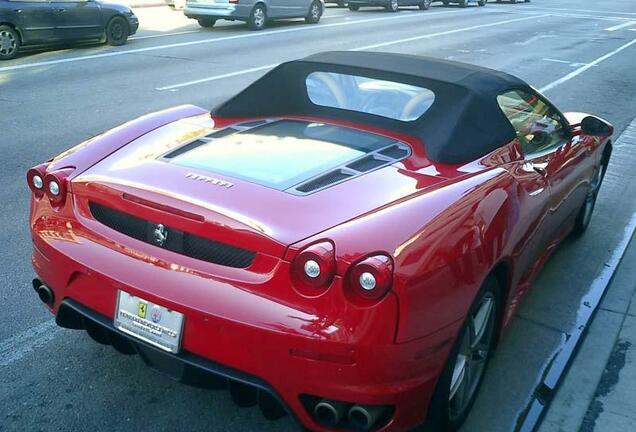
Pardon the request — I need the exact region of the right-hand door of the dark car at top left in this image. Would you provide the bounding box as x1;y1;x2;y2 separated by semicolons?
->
51;0;104;40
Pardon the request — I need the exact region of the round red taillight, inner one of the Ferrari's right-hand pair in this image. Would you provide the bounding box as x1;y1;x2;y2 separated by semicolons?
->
292;241;336;294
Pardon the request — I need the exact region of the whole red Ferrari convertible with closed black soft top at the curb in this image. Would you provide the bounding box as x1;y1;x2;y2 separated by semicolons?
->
27;52;613;431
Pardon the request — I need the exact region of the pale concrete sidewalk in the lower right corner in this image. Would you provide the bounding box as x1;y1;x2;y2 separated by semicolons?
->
539;228;636;432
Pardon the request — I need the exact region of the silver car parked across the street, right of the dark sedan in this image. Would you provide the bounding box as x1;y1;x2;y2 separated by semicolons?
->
183;0;325;30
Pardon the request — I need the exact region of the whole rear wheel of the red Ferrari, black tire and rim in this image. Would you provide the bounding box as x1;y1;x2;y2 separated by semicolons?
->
427;275;501;432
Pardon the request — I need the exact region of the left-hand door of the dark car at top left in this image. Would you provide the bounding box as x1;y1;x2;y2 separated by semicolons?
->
9;0;55;44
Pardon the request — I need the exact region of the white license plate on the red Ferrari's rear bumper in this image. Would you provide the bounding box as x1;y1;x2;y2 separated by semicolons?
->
114;291;183;353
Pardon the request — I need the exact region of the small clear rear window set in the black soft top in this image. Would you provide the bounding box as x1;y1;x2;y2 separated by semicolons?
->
305;72;435;121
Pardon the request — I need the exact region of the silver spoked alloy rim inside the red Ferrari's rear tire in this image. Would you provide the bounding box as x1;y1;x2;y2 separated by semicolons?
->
448;292;496;421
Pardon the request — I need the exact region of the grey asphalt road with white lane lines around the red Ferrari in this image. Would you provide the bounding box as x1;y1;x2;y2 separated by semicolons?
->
0;0;636;432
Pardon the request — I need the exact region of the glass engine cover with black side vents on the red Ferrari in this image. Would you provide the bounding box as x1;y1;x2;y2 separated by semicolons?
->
161;120;410;195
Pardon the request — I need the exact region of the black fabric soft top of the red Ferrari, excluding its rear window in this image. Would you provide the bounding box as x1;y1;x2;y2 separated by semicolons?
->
213;51;529;163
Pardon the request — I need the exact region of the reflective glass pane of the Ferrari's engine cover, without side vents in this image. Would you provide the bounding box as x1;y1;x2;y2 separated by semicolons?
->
164;120;395;190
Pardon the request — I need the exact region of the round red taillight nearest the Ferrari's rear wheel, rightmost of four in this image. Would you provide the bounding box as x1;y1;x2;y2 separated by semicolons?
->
348;255;393;301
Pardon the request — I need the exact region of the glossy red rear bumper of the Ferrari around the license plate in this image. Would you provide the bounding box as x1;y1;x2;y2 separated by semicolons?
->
32;208;456;431
